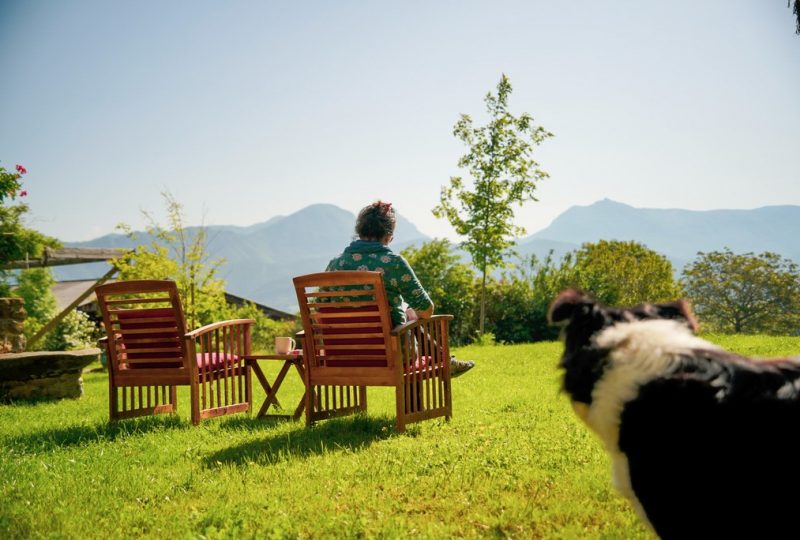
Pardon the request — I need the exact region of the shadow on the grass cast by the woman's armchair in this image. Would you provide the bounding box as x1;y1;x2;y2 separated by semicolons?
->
203;415;404;467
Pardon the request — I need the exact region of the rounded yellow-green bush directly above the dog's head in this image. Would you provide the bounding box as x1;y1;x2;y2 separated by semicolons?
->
572;240;682;306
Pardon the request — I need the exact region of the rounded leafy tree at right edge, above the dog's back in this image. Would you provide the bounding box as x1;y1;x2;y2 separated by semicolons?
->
683;248;800;334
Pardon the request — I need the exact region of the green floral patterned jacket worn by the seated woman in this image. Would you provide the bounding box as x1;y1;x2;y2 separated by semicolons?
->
325;240;433;326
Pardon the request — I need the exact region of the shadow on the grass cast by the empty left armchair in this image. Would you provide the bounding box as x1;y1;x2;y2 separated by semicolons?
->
0;415;192;452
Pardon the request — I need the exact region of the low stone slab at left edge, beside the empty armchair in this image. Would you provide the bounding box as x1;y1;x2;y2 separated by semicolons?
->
0;349;100;401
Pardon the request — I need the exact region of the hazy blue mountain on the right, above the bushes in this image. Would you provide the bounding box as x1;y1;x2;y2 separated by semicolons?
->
519;199;800;267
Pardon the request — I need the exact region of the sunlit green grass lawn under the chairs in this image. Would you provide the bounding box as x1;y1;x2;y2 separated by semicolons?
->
0;336;800;538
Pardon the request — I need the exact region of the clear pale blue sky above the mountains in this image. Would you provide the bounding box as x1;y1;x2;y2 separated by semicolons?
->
0;0;800;241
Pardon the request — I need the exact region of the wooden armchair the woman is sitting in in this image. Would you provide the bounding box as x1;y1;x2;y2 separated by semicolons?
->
294;271;453;432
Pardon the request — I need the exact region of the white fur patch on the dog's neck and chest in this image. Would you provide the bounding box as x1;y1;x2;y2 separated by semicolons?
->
580;319;720;524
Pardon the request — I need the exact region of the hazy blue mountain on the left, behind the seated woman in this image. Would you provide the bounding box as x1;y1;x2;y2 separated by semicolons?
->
54;204;429;312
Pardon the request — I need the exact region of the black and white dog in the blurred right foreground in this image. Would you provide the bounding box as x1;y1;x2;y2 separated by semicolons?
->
550;289;800;539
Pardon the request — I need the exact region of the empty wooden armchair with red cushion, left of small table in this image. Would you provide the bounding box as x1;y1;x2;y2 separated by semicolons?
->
95;280;254;424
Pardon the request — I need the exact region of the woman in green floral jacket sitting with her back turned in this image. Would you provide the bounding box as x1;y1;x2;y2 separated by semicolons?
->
325;201;475;376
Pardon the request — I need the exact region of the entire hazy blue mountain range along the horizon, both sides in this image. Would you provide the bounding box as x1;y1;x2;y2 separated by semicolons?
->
54;199;800;312
